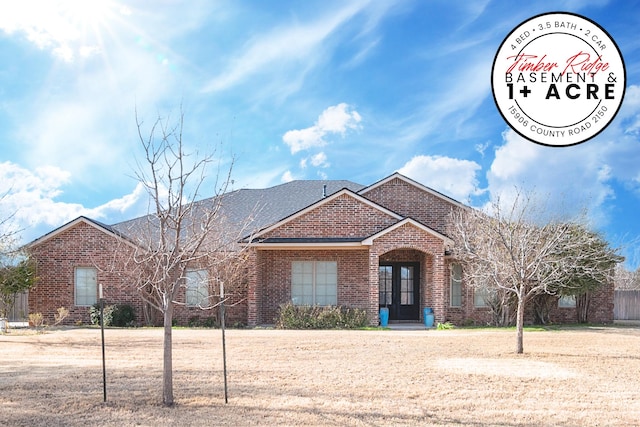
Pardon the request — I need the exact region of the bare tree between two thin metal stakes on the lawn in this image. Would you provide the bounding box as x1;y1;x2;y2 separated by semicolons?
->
115;108;251;406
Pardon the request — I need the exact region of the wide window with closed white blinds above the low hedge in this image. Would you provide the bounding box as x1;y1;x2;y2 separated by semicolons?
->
291;261;338;305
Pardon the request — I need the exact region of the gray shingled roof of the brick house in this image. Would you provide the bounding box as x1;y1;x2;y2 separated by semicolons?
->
111;180;365;241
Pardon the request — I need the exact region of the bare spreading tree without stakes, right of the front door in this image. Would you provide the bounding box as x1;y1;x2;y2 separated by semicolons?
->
449;191;615;353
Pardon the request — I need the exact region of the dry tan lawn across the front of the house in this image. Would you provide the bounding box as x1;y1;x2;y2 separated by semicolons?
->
0;327;640;427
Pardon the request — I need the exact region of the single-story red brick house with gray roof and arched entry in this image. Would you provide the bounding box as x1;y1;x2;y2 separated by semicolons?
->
28;173;613;326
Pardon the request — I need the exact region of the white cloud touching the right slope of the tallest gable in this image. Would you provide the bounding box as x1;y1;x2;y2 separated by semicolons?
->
398;155;481;203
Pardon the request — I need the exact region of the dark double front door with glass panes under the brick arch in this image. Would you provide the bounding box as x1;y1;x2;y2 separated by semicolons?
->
378;262;420;320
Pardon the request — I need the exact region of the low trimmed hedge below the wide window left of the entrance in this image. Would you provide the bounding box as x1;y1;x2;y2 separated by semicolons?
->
276;303;367;329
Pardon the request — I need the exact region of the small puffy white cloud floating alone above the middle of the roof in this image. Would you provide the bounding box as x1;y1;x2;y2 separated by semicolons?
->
282;102;362;154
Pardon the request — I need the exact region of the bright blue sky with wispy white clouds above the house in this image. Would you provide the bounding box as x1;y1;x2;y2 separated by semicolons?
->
0;0;640;268
